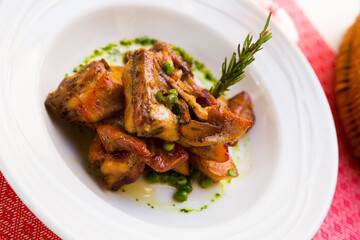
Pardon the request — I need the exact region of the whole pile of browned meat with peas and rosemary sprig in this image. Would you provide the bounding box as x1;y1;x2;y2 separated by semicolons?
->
45;14;271;202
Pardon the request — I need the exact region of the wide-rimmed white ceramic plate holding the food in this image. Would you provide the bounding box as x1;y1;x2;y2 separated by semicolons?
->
0;0;338;240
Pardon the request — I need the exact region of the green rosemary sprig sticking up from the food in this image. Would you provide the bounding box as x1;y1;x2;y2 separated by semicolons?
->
210;12;272;98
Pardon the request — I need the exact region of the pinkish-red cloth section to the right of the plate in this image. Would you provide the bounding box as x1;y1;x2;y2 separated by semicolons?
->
274;0;360;240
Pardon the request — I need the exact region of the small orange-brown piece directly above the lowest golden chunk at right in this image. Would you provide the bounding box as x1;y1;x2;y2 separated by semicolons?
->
188;144;230;162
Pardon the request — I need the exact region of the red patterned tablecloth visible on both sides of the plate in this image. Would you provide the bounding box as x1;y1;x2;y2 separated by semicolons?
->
0;0;360;240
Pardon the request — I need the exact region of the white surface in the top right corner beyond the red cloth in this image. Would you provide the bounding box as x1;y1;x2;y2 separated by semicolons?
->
295;0;360;52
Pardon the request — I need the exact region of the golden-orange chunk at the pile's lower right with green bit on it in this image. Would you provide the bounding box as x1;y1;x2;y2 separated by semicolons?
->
189;154;239;182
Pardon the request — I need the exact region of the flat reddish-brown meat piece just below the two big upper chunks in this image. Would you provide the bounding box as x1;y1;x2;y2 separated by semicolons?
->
96;125;150;156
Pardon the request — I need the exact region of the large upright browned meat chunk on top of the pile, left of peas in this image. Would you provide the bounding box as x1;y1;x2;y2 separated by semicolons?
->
123;48;179;141
